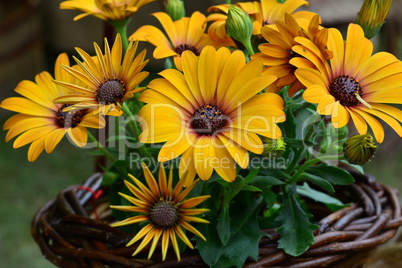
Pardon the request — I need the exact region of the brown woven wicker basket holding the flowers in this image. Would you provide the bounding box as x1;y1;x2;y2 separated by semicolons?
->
31;173;402;268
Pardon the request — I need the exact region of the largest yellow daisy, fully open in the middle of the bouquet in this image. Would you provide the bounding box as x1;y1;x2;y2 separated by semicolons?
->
139;46;285;186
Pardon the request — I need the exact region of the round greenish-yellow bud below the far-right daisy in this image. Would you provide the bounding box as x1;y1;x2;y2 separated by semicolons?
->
343;133;377;165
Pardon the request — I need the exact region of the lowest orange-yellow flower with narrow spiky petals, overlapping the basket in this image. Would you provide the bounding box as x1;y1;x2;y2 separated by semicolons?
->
110;163;211;260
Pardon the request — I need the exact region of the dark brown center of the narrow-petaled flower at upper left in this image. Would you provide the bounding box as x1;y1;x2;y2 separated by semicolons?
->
96;80;125;104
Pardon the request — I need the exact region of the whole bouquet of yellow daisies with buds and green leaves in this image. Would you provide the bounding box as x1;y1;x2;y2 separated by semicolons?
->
0;0;402;267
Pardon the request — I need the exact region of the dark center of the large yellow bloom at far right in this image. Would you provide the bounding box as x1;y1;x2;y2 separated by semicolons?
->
329;75;363;106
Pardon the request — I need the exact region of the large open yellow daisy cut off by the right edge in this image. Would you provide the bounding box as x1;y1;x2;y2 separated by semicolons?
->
291;24;402;143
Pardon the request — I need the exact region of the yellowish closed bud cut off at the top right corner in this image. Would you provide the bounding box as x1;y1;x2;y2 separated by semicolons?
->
356;0;392;39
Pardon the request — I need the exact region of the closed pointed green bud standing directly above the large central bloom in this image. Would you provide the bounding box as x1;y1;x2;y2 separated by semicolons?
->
226;5;253;52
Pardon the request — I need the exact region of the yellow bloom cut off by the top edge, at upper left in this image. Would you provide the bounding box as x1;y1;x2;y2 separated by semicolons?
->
60;0;155;21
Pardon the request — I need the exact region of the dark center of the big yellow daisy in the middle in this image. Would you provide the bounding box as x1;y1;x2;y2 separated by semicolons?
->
191;104;228;135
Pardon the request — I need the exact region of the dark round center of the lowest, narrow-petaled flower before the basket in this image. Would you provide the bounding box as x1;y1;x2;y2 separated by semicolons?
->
149;201;178;228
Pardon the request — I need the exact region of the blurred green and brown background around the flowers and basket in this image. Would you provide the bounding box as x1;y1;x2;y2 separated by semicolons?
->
0;0;402;268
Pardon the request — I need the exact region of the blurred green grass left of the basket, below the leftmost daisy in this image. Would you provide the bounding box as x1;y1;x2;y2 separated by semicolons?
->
0;116;94;268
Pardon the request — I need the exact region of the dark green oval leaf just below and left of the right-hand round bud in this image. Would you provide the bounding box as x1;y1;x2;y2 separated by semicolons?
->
306;163;355;185
